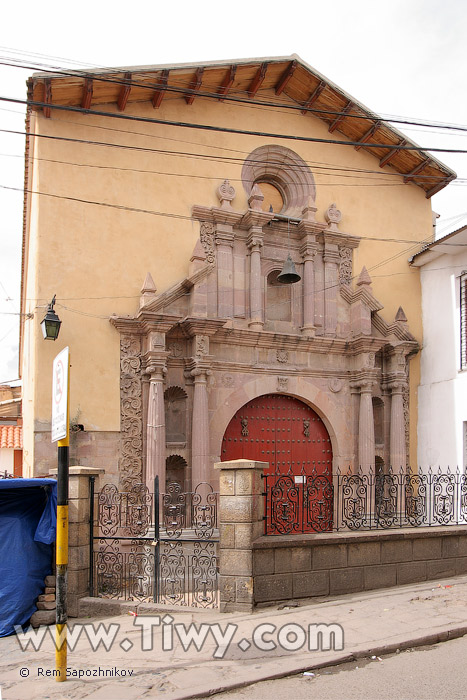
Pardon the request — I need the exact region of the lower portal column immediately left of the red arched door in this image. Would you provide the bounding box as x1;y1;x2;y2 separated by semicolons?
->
191;367;211;490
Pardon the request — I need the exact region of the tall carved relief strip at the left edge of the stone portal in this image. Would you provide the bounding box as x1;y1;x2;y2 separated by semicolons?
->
119;335;143;491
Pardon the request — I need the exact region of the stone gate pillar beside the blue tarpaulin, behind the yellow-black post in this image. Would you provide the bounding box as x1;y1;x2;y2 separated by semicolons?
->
51;466;105;617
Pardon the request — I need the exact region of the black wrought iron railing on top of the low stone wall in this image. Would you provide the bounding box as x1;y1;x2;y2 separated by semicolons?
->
264;468;467;535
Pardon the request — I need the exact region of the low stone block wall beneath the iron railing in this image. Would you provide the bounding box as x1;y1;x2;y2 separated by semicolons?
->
253;526;467;605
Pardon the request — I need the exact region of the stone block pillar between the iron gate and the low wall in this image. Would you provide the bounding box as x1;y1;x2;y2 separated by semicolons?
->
214;459;269;612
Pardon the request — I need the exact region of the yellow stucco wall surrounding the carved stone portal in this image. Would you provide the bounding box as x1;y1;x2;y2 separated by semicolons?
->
23;90;432;463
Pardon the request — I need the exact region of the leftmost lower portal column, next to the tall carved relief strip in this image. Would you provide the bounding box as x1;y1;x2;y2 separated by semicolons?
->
146;365;167;493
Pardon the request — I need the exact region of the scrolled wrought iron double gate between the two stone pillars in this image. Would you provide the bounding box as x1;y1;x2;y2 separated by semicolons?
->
90;479;218;607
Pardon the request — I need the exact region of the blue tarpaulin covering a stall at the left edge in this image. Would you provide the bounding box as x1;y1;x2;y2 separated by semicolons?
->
0;479;57;637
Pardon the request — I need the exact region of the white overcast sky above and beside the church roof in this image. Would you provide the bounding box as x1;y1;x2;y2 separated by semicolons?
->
0;0;467;382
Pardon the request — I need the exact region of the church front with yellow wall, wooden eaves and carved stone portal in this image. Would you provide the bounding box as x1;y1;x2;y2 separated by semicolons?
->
21;57;454;491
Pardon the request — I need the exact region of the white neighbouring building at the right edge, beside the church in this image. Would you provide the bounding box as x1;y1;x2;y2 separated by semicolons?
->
410;226;467;471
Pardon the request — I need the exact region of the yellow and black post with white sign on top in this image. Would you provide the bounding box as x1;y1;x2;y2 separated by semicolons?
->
52;348;70;683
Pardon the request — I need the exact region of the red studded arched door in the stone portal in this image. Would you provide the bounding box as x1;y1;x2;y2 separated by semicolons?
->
221;394;333;534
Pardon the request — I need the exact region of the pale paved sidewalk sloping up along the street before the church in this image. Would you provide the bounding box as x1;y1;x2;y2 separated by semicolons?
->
0;576;467;700
